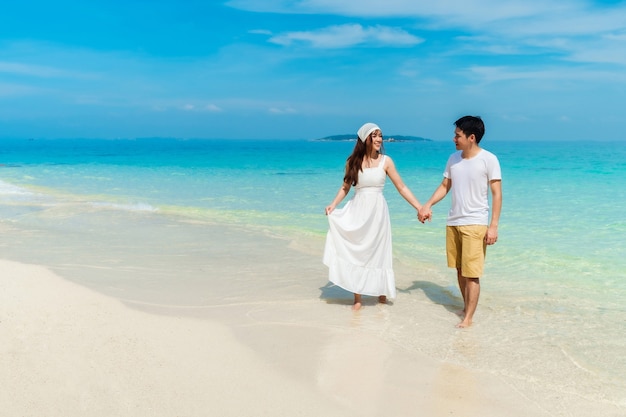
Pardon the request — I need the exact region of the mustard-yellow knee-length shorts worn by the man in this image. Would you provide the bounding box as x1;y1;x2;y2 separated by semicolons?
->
446;225;487;278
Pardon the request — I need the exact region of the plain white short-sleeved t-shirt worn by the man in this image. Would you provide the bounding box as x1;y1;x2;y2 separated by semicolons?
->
443;149;502;226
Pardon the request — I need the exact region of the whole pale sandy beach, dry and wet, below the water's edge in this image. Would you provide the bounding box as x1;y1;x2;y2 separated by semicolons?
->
0;203;623;417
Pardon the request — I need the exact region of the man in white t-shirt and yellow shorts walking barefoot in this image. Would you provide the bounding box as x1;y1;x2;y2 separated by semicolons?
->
418;116;502;327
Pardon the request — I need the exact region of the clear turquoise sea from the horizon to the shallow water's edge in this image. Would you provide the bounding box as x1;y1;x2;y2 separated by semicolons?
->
0;138;626;415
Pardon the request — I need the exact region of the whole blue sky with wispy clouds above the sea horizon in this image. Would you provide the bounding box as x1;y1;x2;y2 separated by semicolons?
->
0;0;626;140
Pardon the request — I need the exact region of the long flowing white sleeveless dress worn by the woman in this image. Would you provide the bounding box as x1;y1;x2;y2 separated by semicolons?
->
323;156;396;298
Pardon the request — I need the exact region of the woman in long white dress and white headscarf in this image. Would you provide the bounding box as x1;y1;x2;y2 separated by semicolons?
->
324;123;421;310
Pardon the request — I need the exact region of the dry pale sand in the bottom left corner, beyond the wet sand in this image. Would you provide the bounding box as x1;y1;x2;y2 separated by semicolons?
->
0;261;356;416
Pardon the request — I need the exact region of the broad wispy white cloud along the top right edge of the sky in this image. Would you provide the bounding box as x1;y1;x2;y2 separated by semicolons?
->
227;0;626;38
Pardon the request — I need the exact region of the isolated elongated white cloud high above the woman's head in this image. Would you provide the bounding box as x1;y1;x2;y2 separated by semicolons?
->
269;24;423;48
